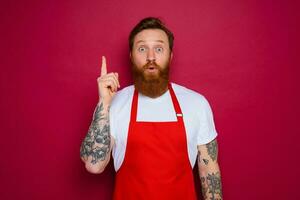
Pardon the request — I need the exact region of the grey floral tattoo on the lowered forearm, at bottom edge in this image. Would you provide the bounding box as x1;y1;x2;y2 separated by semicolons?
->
200;172;223;200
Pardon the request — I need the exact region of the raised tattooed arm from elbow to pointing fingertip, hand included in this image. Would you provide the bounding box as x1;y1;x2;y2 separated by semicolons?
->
80;56;120;174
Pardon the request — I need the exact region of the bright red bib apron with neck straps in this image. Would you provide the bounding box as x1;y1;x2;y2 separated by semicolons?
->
114;85;196;200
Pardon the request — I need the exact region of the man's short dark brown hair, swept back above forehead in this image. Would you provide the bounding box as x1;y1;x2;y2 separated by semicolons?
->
129;17;174;51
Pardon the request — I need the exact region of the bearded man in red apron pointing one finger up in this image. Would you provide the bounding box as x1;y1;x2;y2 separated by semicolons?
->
80;18;222;200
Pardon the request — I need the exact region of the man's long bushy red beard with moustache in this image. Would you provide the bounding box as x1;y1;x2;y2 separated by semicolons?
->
131;61;169;98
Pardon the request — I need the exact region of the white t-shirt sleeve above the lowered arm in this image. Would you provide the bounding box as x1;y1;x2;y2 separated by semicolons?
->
197;96;217;145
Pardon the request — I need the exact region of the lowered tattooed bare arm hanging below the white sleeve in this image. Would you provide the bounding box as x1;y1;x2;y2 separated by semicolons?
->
197;139;223;200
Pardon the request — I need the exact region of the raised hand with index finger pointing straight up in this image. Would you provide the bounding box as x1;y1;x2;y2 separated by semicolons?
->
97;56;120;104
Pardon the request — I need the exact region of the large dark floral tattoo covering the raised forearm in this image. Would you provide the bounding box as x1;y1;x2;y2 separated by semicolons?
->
80;102;111;164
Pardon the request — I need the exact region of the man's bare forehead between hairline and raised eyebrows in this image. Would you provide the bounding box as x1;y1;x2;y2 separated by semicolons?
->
133;29;169;44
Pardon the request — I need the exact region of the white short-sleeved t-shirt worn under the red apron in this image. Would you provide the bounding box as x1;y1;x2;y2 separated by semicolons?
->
109;83;217;171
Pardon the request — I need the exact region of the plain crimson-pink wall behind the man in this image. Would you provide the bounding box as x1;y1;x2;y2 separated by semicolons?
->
0;0;300;200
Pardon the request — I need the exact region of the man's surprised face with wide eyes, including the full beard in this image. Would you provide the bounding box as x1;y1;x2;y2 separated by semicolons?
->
130;29;172;97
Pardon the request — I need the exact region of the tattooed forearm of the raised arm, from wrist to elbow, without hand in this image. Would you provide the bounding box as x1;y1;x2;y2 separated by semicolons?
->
80;100;111;173
